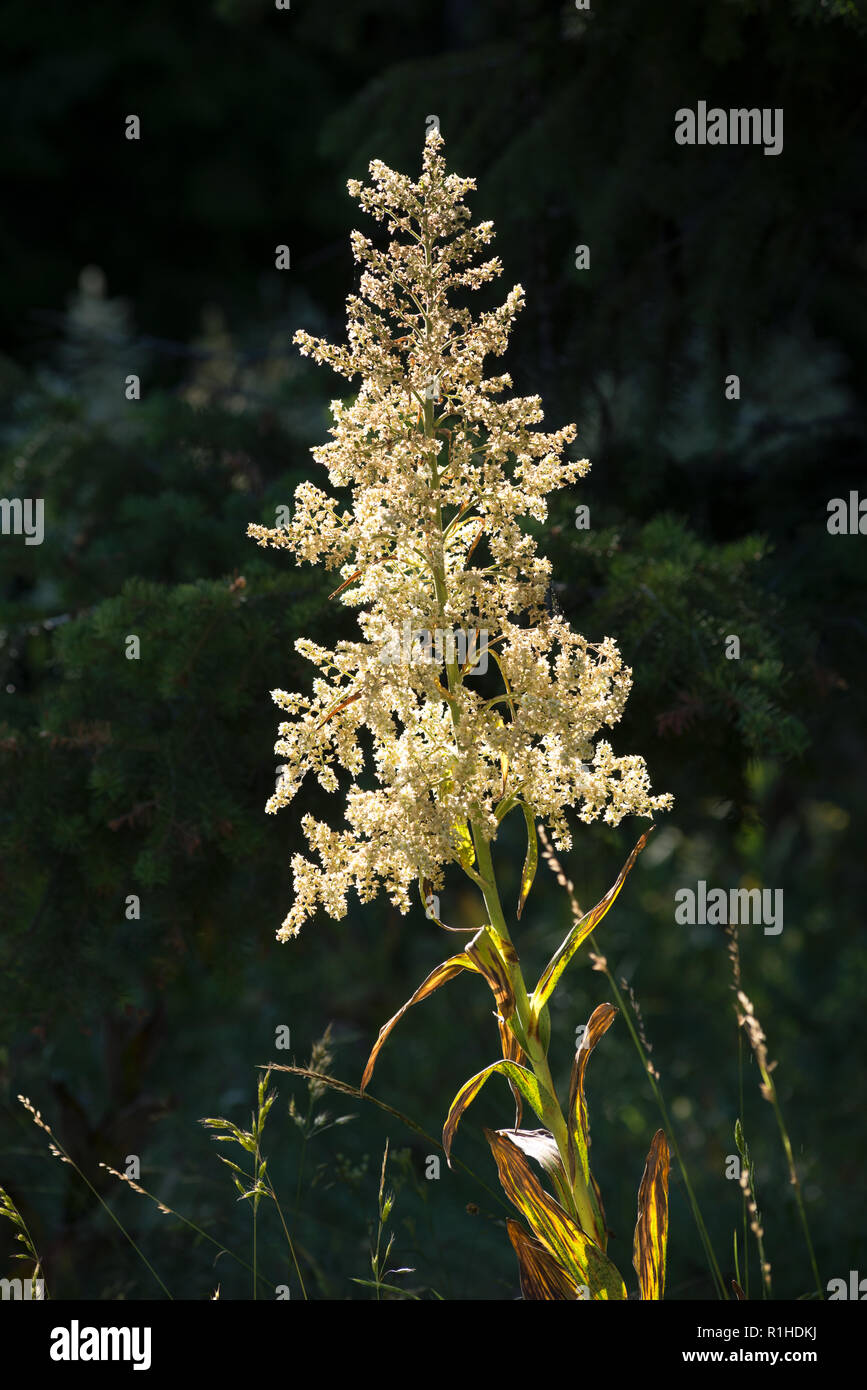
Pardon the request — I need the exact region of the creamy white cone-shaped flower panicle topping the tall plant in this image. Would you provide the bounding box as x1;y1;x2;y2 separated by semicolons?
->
249;131;672;940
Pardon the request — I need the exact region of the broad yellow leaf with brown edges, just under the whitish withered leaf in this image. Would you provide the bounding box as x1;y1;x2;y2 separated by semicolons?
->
485;1129;627;1300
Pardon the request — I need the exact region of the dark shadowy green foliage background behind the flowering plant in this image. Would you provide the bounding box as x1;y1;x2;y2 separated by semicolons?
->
0;0;867;1298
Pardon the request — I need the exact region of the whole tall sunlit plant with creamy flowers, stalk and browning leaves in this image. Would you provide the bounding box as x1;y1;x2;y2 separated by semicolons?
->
249;131;672;1298
